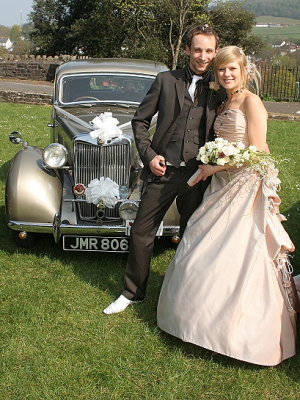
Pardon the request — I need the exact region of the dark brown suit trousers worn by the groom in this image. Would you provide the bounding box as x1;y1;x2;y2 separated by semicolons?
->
122;166;209;300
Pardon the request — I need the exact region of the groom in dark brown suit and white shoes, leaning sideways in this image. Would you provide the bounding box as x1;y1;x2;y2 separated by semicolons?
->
104;25;224;314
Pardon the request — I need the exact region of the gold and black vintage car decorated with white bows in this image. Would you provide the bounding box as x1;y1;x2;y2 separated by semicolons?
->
5;59;179;252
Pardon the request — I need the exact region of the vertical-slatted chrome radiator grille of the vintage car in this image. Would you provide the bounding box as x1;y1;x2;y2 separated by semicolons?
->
74;141;130;220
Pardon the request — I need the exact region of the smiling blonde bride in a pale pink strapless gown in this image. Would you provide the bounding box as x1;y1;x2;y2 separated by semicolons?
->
157;46;299;366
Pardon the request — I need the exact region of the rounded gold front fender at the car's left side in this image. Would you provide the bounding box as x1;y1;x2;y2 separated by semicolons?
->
5;146;62;223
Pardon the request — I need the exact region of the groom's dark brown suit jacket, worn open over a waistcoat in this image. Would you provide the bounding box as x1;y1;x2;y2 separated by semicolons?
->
132;69;225;180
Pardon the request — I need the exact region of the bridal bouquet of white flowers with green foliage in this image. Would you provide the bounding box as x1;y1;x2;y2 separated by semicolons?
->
187;138;275;186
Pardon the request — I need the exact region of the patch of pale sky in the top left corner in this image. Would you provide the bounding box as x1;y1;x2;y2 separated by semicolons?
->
0;0;33;26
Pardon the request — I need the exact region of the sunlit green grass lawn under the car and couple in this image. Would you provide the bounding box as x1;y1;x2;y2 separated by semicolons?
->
0;103;300;400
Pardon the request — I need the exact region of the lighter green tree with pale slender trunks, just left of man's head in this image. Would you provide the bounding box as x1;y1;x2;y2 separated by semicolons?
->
115;0;208;69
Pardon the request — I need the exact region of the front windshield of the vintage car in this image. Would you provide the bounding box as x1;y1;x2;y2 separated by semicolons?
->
59;74;155;104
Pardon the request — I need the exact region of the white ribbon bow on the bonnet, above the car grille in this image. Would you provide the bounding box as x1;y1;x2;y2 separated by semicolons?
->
90;112;122;144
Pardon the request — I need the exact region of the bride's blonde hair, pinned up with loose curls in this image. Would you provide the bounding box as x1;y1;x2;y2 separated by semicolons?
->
213;46;261;94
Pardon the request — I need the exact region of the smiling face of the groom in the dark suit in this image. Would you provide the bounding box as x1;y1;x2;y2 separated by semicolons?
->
185;34;217;74
